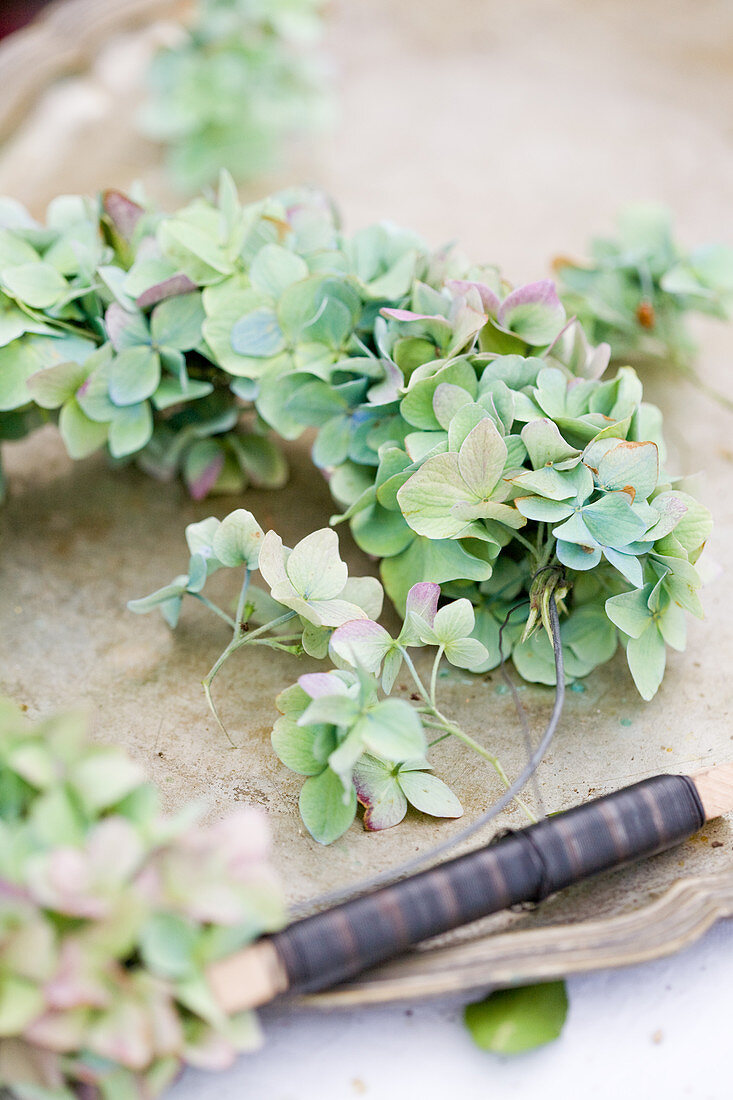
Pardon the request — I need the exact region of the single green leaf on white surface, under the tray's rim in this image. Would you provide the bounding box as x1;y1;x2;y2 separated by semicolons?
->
463;981;568;1054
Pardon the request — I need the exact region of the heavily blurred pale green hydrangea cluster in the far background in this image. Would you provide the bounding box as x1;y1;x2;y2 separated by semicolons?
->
140;0;328;191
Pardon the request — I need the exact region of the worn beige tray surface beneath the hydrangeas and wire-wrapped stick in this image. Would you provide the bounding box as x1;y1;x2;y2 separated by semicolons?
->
0;0;733;954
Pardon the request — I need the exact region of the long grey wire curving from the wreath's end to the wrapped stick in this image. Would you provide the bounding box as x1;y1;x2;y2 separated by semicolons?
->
291;596;565;916
